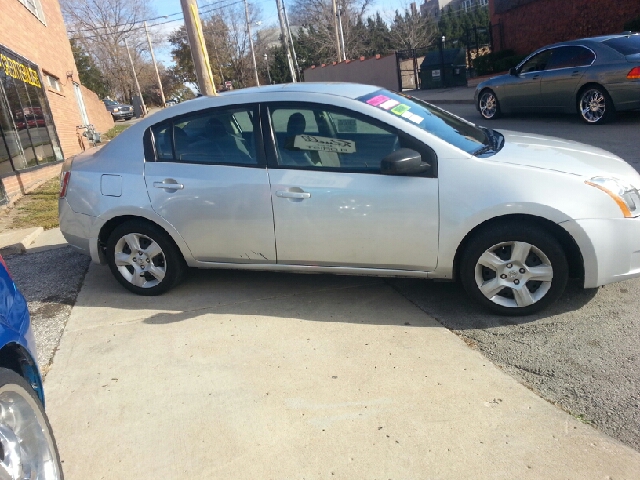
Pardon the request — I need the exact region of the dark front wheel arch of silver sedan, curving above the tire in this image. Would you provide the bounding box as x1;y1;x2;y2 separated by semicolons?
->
453;214;584;280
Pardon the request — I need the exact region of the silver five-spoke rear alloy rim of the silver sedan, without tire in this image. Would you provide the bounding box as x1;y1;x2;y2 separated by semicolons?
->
114;233;167;288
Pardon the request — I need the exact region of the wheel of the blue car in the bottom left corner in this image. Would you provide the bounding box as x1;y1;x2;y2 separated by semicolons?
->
0;368;64;480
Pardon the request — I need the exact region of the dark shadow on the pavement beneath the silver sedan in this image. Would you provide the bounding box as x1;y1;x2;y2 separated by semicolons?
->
76;265;597;330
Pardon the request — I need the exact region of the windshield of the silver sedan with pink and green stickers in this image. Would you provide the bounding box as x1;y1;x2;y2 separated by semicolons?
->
358;89;492;154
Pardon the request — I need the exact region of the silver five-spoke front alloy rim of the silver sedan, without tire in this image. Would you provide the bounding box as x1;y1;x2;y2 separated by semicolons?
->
475;241;553;308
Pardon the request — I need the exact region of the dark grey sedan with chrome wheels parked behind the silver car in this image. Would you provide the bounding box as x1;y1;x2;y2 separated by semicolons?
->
475;33;640;125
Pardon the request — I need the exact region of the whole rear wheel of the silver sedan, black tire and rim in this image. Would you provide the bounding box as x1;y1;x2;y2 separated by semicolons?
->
106;220;187;296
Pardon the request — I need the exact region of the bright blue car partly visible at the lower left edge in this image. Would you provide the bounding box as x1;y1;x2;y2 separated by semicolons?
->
0;256;63;480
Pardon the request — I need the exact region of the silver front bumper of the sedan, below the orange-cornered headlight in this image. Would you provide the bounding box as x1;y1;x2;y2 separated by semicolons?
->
560;217;640;288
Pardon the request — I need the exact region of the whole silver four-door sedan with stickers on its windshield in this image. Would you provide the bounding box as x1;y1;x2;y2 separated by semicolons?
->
60;83;640;315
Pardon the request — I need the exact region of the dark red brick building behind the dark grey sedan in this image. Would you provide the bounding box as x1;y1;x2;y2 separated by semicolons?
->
489;0;640;55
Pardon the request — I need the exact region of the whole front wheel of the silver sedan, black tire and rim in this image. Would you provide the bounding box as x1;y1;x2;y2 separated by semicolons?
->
459;222;569;316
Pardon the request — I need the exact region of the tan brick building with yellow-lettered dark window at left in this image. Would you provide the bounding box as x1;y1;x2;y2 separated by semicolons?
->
0;0;113;203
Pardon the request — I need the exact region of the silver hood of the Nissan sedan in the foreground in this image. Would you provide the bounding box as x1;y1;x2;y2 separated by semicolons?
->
488;130;640;183
